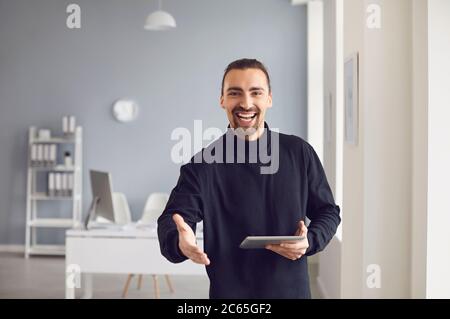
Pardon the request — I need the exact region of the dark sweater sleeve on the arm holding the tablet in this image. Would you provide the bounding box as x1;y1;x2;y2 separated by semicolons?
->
304;143;341;256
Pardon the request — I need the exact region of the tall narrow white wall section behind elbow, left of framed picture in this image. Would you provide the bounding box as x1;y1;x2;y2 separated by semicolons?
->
317;0;344;298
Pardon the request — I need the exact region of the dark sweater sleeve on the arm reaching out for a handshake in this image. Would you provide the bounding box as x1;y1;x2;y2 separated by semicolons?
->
158;163;203;263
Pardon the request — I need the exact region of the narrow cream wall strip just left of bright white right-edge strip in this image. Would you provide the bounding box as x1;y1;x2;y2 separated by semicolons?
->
410;0;428;298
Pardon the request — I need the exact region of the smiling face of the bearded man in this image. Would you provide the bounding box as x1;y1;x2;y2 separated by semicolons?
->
220;69;272;130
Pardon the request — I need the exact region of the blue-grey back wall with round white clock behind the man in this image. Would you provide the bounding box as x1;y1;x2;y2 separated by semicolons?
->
0;0;306;244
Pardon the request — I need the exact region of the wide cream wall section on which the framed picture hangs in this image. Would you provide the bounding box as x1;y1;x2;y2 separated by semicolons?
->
342;0;412;298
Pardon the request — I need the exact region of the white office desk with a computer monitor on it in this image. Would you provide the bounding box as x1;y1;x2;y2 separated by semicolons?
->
65;228;206;299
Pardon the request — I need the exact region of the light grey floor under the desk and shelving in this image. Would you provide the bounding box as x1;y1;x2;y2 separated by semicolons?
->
0;252;320;299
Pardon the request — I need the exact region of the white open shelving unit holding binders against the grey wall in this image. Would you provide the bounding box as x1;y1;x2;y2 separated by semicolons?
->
25;126;83;258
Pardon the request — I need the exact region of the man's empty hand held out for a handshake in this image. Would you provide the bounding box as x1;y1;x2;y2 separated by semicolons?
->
172;214;210;265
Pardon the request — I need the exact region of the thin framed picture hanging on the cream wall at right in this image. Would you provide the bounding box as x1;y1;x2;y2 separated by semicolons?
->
344;52;359;145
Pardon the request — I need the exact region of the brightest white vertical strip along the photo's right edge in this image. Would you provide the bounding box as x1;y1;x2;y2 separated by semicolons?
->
426;0;450;298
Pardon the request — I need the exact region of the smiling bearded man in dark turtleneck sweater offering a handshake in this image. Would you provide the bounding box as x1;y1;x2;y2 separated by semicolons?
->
158;59;340;298
